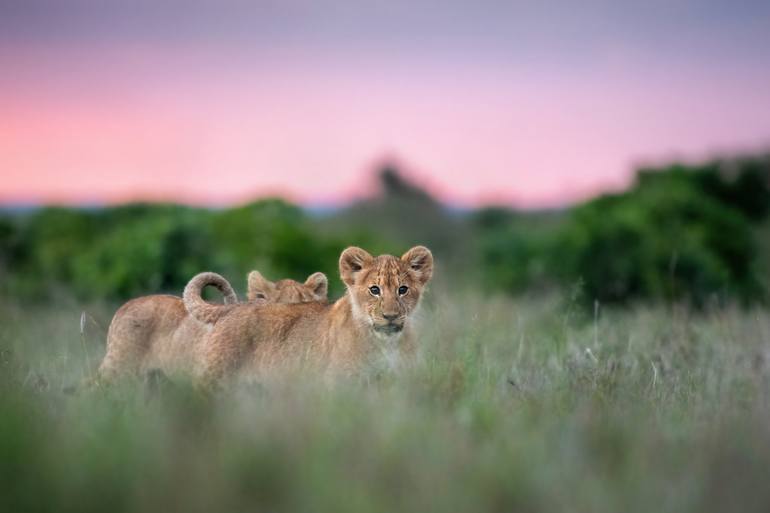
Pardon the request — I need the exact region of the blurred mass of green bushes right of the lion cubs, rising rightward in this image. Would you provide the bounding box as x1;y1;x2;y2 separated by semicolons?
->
474;157;770;306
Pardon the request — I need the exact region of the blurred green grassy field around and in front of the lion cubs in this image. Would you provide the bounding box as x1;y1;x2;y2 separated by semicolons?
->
0;292;770;513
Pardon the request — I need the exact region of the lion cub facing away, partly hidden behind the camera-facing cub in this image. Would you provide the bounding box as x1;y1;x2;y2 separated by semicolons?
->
99;271;328;381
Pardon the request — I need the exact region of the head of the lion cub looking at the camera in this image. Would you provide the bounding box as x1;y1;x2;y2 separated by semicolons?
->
340;246;433;336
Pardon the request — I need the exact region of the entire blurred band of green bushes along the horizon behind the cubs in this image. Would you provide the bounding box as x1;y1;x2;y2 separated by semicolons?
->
0;151;770;306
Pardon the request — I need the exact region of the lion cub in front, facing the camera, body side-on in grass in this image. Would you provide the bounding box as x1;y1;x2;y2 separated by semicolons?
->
191;246;433;385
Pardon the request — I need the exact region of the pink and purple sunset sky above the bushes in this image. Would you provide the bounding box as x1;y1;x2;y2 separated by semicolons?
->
0;0;770;207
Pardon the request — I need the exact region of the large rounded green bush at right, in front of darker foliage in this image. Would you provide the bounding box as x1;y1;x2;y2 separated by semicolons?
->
551;174;762;305
